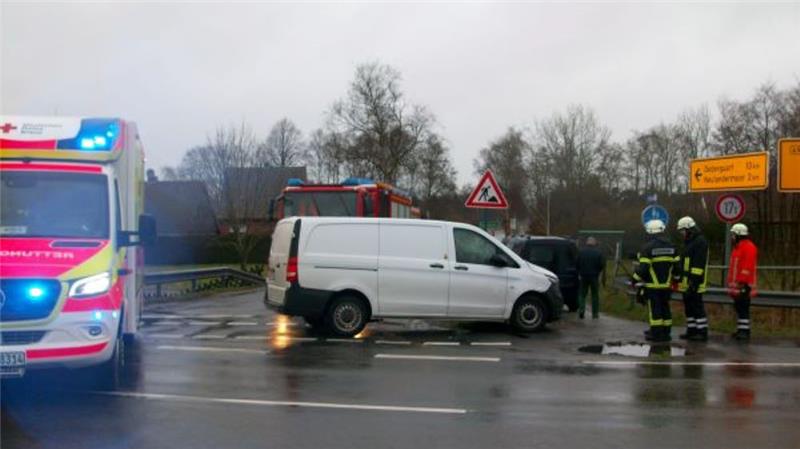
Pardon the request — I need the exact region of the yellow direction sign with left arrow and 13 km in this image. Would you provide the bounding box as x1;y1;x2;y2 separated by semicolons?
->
689;152;769;192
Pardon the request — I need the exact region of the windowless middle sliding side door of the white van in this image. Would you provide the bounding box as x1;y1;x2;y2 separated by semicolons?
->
378;221;450;316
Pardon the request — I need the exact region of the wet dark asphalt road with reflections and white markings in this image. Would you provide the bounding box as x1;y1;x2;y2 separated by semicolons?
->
0;292;800;449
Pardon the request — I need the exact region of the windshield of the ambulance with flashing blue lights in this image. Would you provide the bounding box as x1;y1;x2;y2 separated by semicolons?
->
0;171;109;238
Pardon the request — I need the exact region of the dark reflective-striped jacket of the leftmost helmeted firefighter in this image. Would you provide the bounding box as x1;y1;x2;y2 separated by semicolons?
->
633;235;680;290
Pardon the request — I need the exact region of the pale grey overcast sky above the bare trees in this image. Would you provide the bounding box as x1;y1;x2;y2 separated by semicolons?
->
0;2;800;183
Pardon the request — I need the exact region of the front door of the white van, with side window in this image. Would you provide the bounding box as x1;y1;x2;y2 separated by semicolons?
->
447;227;513;318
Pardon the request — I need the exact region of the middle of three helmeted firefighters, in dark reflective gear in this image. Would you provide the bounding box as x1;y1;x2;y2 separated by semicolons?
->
675;217;708;341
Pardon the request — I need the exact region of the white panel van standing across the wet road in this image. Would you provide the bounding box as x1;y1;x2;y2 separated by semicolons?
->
265;217;563;336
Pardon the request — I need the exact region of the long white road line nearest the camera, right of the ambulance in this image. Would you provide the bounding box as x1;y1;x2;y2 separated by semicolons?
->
95;391;468;415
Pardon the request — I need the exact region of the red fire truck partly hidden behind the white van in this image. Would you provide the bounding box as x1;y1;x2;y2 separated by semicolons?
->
270;178;421;220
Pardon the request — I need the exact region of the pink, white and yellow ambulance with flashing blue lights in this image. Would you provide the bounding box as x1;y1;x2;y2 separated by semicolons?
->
0;116;156;385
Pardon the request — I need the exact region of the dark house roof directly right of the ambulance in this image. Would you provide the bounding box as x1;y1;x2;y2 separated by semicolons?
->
144;181;217;236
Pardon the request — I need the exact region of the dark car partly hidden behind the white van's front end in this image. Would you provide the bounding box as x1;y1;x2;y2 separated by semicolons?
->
506;236;579;312
